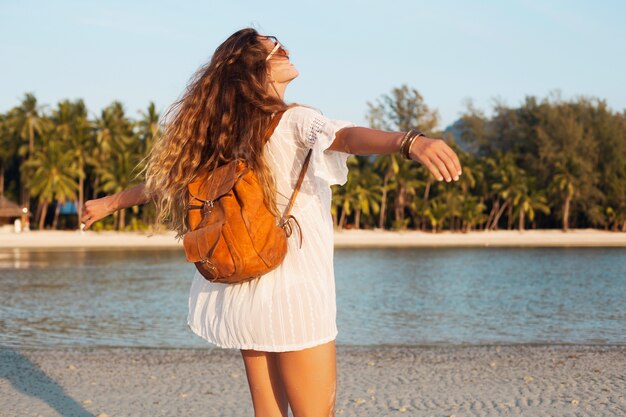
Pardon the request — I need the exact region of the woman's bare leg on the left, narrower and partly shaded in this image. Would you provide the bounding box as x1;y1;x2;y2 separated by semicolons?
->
241;350;287;417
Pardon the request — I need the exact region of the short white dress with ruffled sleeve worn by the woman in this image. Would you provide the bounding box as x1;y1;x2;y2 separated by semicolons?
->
187;107;354;352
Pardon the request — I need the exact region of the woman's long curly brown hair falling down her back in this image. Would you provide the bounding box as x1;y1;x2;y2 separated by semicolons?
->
144;28;288;239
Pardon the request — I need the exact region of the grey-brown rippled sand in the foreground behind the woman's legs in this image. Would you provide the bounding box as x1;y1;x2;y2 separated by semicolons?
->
0;345;626;417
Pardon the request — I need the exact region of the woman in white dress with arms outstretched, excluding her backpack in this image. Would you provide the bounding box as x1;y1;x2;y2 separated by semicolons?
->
83;29;461;417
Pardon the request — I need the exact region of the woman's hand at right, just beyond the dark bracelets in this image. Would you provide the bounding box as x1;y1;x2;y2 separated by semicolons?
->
409;136;461;182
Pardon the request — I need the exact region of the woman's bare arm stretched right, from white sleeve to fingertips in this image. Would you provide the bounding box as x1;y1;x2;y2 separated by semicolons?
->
329;127;461;182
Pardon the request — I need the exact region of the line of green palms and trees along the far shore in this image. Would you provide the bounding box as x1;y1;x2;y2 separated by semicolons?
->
0;85;626;232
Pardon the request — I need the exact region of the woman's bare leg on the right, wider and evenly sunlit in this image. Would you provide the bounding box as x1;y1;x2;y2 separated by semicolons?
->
276;341;337;417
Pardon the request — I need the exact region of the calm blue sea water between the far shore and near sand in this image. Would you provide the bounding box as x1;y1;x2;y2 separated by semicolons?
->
0;248;626;348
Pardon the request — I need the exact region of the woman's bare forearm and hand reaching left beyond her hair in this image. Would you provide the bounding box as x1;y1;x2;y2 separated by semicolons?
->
81;182;150;230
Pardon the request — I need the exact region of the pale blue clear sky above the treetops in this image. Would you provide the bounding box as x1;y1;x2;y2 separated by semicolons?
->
0;0;626;129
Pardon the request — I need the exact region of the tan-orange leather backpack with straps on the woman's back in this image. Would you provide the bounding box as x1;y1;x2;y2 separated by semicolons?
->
183;111;311;284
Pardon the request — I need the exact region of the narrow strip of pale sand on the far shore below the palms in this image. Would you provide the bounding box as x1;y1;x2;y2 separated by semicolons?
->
0;229;626;249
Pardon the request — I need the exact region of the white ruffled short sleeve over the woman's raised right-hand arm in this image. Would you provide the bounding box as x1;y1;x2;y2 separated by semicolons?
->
291;107;356;185
